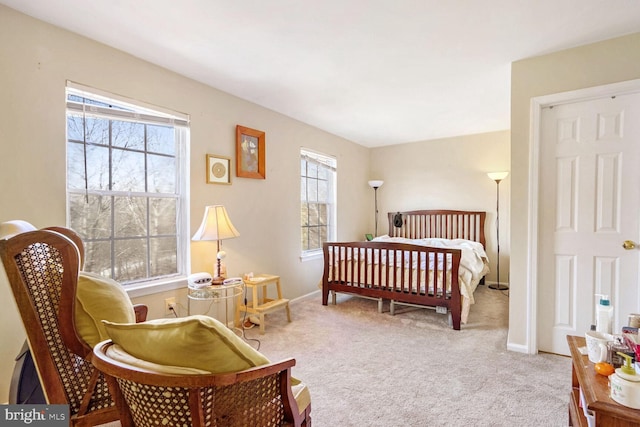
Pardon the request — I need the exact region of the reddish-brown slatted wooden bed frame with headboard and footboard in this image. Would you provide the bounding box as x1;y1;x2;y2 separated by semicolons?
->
322;210;486;330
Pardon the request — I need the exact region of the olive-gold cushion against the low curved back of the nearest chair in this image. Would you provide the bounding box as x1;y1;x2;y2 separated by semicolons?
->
104;315;269;374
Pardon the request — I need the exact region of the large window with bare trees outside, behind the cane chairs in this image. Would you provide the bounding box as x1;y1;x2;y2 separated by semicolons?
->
66;84;189;285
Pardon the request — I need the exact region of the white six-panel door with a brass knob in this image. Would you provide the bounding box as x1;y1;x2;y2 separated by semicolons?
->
538;94;640;354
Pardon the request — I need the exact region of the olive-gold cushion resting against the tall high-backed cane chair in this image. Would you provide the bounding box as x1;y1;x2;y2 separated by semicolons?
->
75;272;136;347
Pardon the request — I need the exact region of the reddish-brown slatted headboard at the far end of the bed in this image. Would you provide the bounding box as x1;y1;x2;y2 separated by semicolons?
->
388;210;487;247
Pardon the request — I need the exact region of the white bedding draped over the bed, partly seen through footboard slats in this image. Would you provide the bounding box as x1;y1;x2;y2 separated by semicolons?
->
330;235;489;323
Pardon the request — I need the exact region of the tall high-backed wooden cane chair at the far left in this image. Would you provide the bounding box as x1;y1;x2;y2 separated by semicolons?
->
0;223;146;426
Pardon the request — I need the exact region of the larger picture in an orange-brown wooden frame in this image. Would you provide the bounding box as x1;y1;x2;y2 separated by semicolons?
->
236;125;266;179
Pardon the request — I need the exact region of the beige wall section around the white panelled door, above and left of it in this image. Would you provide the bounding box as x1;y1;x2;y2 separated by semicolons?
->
508;33;640;351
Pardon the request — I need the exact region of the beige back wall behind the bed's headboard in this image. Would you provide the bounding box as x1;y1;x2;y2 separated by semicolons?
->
370;130;510;282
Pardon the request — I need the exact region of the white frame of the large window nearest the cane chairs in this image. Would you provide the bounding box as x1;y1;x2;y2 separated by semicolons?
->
65;81;190;297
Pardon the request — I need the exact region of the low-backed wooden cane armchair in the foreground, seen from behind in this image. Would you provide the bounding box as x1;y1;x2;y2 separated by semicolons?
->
93;341;311;427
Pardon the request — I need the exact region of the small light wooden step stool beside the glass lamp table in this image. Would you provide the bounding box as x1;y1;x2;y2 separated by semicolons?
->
235;274;291;334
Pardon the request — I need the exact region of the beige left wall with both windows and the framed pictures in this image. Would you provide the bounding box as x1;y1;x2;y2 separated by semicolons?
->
0;6;373;402
